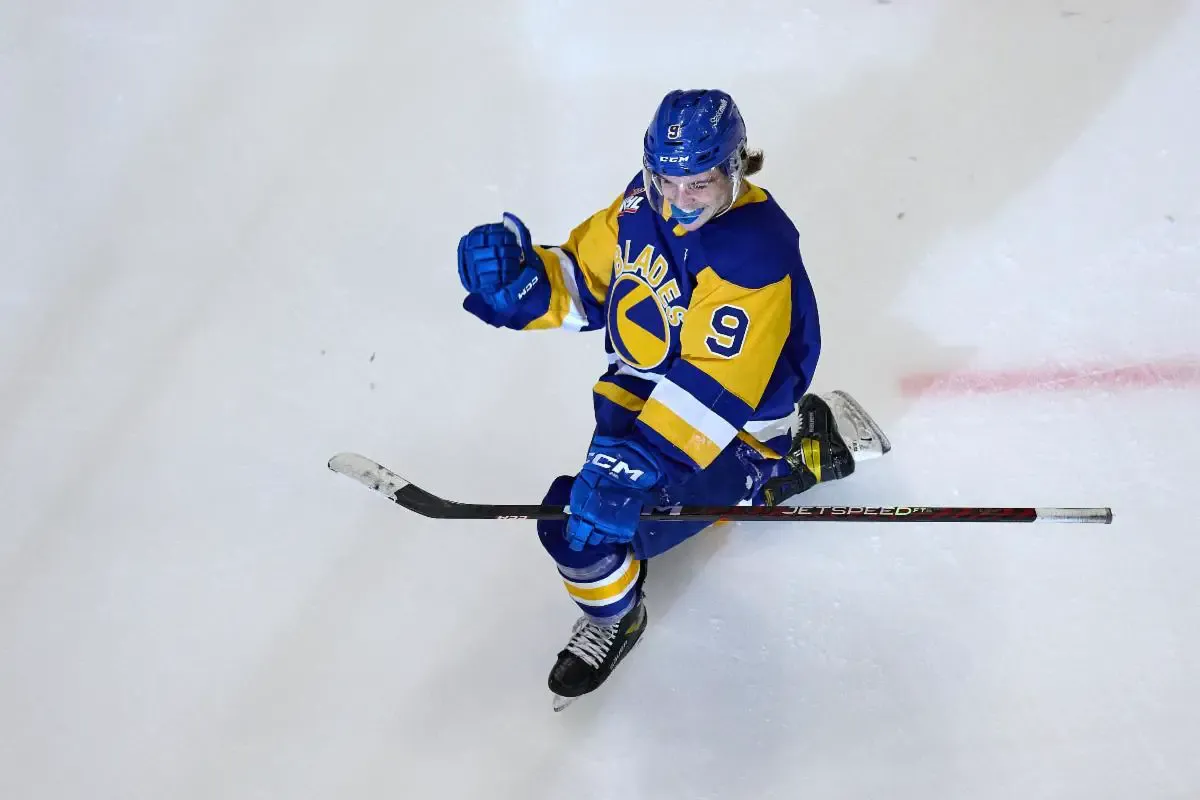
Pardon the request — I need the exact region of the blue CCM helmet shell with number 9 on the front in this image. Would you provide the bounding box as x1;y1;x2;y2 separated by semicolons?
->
644;89;746;176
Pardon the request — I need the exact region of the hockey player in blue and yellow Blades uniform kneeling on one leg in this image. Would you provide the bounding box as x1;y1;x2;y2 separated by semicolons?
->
458;90;889;709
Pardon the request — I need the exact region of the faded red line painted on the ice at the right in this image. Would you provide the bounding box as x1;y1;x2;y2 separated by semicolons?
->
900;359;1200;397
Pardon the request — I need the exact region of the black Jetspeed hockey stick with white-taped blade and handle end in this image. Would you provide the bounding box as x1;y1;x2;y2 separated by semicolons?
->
329;453;1112;524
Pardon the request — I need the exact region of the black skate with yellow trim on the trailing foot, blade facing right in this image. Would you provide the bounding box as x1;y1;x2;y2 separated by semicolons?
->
762;391;892;506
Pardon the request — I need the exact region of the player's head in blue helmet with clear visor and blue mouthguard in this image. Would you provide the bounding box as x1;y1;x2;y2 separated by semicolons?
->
642;89;746;230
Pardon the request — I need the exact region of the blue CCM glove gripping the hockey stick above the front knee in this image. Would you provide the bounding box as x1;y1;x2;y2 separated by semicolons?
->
563;435;662;551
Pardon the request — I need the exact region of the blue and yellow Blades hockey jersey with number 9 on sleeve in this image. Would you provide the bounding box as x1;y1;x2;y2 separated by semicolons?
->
467;175;821;483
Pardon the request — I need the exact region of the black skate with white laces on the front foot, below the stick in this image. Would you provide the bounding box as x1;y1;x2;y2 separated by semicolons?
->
547;561;647;711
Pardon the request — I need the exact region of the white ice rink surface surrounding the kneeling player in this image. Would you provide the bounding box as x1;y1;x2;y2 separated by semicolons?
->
0;0;1200;800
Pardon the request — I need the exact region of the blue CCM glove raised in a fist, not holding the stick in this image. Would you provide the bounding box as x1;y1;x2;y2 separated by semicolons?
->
458;212;546;325
